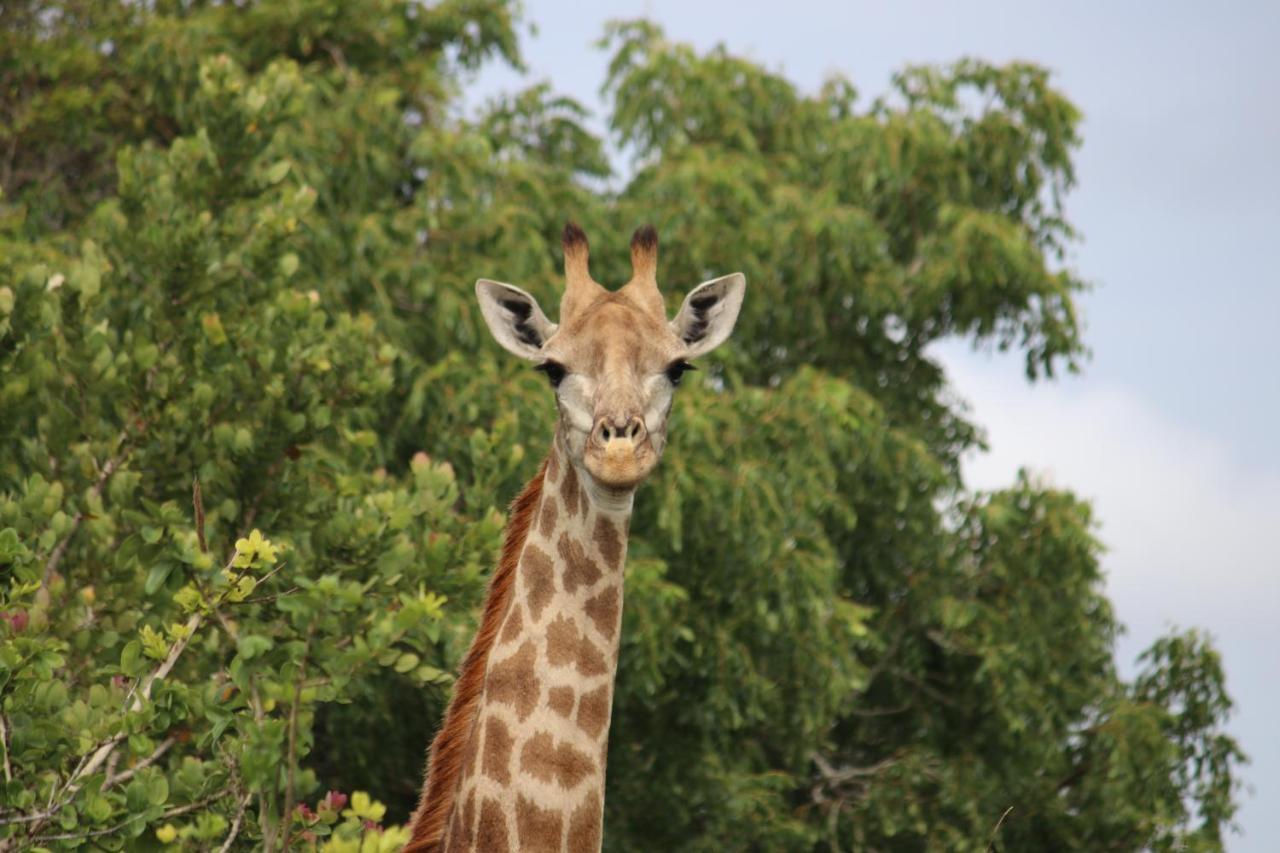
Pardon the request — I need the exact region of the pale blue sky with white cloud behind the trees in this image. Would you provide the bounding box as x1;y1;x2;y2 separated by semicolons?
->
467;0;1280;852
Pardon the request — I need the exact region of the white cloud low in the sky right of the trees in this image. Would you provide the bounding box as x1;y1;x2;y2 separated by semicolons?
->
942;348;1280;850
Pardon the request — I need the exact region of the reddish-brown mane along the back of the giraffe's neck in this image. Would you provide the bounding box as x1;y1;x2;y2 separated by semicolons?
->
404;461;547;853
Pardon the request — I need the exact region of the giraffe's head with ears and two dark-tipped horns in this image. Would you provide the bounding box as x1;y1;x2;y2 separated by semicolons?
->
476;223;746;492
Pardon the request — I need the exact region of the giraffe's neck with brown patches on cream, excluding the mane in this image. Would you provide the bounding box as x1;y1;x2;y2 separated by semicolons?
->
443;438;631;853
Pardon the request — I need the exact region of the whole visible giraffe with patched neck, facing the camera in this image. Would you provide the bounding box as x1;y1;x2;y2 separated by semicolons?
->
404;223;746;853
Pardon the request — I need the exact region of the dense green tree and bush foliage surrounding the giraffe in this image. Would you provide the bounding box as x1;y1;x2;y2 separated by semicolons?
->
0;0;1243;850
